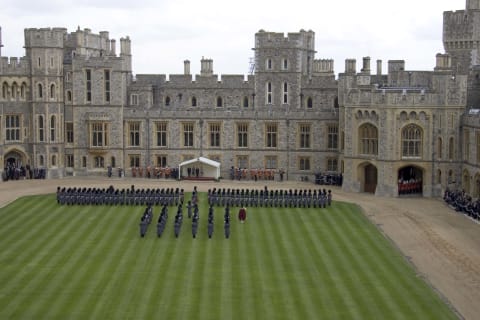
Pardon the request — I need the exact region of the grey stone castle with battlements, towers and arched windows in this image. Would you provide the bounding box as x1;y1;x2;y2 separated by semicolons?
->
0;0;480;197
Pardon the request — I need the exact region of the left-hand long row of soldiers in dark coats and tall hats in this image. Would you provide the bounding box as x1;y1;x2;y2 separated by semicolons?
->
57;185;184;206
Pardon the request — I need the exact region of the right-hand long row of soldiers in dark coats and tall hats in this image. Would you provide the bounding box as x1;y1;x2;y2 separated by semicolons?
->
208;187;332;208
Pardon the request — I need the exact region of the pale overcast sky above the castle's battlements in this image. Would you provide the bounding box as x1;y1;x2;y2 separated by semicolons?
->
0;0;465;75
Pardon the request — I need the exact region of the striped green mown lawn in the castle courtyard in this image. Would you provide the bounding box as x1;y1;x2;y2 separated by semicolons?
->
0;194;457;320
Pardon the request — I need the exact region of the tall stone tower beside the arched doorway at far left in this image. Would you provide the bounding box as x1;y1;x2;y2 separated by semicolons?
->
25;28;67;178
